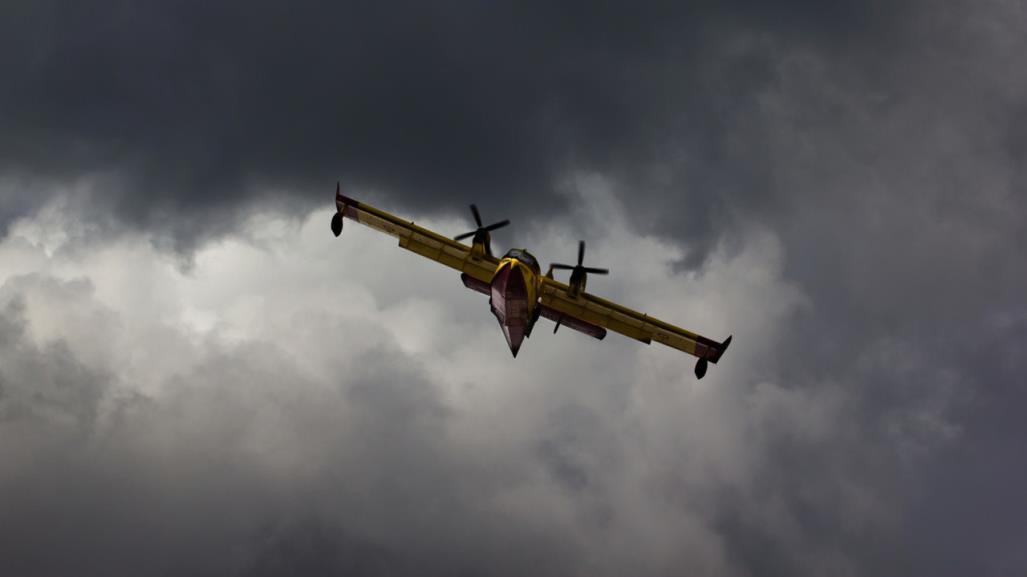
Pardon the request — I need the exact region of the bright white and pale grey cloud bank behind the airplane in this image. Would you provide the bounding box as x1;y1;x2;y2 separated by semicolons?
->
0;177;961;575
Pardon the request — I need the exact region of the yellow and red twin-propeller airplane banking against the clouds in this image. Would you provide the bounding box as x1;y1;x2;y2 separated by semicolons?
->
332;183;731;379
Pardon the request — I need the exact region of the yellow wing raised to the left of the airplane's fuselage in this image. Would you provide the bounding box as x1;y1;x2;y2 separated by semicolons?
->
332;186;499;282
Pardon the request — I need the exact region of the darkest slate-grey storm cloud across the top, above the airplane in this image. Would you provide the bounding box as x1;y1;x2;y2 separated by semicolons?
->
6;0;905;247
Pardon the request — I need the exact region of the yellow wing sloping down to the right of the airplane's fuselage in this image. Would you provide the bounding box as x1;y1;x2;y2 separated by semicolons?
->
541;276;731;359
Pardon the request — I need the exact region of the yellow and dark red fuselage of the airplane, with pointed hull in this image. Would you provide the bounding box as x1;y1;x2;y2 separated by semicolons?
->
489;248;541;356
